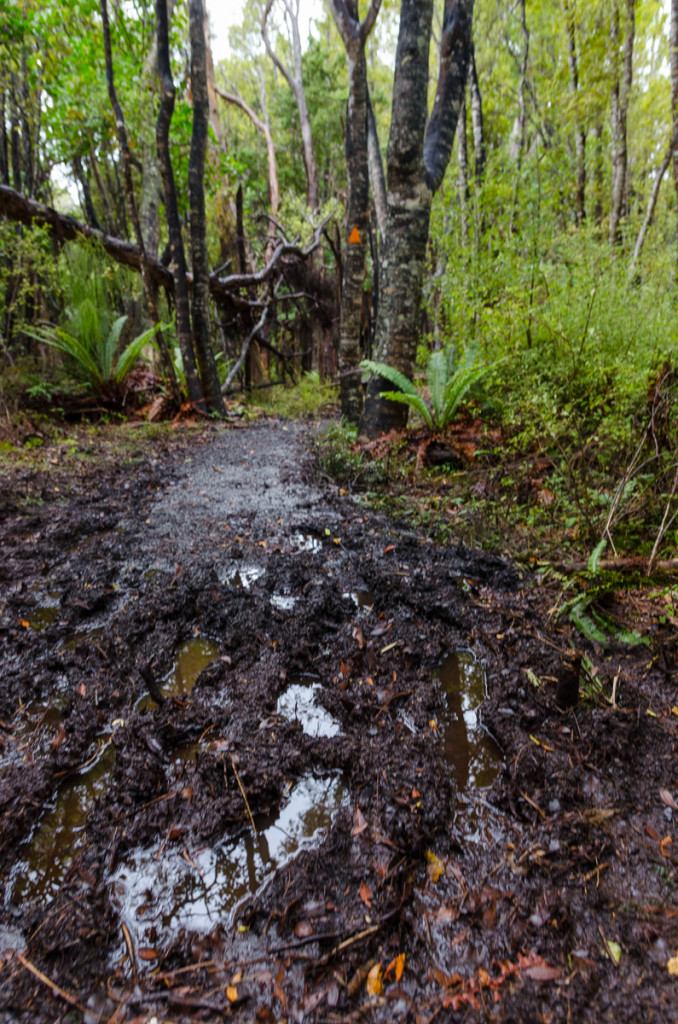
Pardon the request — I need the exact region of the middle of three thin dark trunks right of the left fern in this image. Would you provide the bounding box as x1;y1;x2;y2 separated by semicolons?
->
156;0;206;412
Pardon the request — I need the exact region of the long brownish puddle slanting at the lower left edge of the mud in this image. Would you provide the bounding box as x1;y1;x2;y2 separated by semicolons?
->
8;742;116;905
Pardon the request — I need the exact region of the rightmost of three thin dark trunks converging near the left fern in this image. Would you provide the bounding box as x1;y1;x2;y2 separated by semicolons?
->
188;0;225;416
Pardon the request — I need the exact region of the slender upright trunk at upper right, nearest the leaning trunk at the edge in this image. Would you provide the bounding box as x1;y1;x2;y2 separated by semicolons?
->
609;0;636;245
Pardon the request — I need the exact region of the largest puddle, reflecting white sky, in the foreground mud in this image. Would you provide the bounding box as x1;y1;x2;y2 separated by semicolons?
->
113;775;346;941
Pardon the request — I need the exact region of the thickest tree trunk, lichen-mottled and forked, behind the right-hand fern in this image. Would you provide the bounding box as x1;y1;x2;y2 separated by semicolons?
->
359;0;473;437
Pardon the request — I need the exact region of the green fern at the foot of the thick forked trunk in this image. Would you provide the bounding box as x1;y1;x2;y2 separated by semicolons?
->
361;351;485;432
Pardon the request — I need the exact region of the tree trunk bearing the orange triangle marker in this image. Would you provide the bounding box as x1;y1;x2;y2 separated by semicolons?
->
331;0;381;424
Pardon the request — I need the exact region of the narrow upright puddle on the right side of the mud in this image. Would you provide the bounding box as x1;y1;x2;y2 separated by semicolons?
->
437;651;502;792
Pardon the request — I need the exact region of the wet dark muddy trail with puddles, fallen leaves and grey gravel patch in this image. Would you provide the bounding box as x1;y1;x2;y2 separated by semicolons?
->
0;422;678;1024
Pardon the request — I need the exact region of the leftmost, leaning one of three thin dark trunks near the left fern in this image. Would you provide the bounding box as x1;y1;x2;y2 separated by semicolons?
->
100;0;181;406
